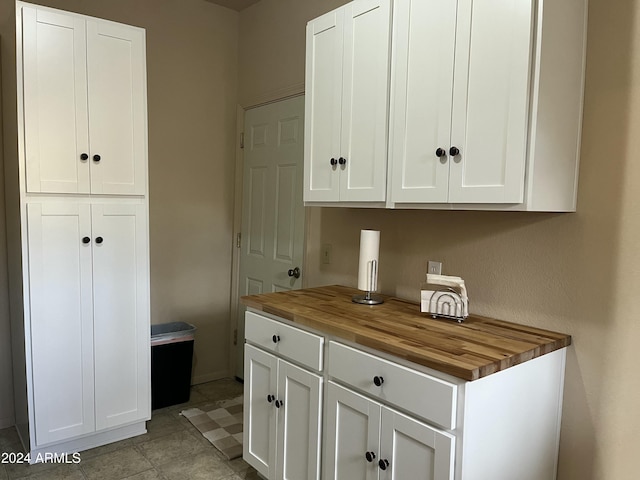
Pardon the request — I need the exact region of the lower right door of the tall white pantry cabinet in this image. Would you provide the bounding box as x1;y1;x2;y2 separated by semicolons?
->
91;204;151;430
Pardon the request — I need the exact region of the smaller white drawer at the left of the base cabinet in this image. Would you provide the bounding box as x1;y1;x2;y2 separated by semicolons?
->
245;312;324;372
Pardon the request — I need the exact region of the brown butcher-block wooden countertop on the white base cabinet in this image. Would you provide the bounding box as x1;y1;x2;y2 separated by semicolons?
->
241;285;571;380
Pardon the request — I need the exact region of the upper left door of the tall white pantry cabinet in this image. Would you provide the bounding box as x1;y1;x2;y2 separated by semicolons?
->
18;6;89;193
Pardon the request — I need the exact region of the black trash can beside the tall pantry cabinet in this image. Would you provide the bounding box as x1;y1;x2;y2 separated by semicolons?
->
151;322;196;410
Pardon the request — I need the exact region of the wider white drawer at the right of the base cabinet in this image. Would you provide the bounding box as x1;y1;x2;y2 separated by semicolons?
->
329;342;458;429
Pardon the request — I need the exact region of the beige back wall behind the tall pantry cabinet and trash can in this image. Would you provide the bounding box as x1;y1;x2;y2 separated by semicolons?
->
0;0;239;424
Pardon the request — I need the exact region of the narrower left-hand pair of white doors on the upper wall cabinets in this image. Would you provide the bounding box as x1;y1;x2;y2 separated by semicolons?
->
304;0;391;202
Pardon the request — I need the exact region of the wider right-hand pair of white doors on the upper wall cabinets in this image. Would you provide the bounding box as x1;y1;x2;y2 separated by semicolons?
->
391;0;534;203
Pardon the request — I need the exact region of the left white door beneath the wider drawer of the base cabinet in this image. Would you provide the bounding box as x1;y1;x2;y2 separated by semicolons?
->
323;382;380;480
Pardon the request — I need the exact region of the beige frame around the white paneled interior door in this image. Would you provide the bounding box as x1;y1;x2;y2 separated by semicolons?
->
229;93;311;378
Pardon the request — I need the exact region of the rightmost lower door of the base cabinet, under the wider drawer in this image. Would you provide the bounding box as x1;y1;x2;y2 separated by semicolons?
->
380;407;455;480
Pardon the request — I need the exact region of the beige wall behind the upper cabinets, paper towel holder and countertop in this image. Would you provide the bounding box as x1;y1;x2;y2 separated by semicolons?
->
240;0;640;480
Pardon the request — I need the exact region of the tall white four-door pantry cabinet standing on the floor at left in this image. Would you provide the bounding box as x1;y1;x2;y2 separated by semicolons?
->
7;2;151;462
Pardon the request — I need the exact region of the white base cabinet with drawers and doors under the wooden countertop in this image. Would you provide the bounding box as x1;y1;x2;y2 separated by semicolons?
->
244;311;566;480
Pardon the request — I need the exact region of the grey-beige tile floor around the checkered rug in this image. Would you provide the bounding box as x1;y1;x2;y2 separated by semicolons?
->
0;379;260;480
